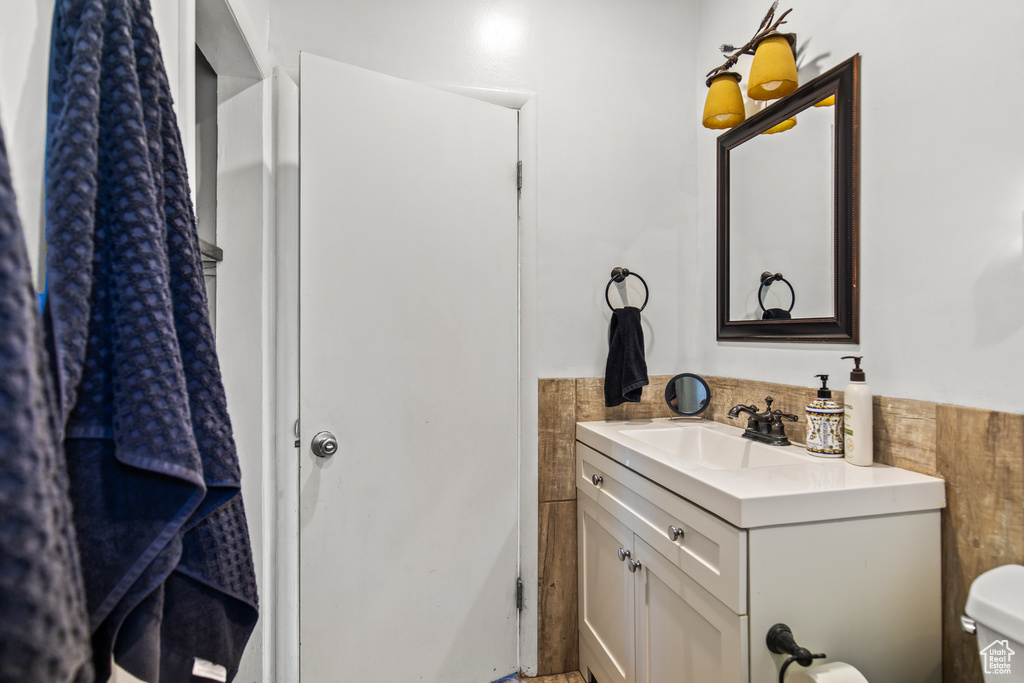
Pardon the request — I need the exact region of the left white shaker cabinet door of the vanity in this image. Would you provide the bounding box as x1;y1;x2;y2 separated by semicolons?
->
577;496;635;683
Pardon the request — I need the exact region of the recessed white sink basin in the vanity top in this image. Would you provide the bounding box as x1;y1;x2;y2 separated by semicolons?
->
620;425;813;470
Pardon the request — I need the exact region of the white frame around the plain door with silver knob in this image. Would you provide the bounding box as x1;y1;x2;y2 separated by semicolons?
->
276;68;539;681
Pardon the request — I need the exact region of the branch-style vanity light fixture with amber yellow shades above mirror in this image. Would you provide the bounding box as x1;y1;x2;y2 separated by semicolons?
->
703;0;799;132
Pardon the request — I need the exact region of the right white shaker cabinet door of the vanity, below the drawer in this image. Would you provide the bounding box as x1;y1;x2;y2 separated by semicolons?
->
634;537;750;683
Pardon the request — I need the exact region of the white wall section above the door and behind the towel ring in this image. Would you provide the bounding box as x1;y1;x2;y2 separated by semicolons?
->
270;0;698;378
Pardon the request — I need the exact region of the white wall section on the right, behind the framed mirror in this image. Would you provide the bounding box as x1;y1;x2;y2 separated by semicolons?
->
692;0;1024;413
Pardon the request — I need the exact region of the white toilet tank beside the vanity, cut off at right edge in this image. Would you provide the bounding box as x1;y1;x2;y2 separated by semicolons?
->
961;564;1024;683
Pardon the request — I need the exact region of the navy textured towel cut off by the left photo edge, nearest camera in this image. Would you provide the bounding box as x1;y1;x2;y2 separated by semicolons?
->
0;109;92;683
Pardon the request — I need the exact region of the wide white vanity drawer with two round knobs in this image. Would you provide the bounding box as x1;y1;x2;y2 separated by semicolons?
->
577;441;746;614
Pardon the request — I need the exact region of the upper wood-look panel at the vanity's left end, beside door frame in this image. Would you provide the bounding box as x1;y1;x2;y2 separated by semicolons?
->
538;379;577;503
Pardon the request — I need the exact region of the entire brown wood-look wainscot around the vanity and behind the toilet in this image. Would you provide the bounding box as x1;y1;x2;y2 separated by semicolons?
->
538;375;1024;683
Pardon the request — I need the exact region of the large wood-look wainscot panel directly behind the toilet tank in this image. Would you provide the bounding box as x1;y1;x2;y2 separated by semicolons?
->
935;404;1024;683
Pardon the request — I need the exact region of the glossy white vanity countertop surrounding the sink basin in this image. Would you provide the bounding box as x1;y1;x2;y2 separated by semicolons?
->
577;418;945;528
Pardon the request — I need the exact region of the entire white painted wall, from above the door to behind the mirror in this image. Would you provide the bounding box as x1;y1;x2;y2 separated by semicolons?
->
269;0;1024;412
